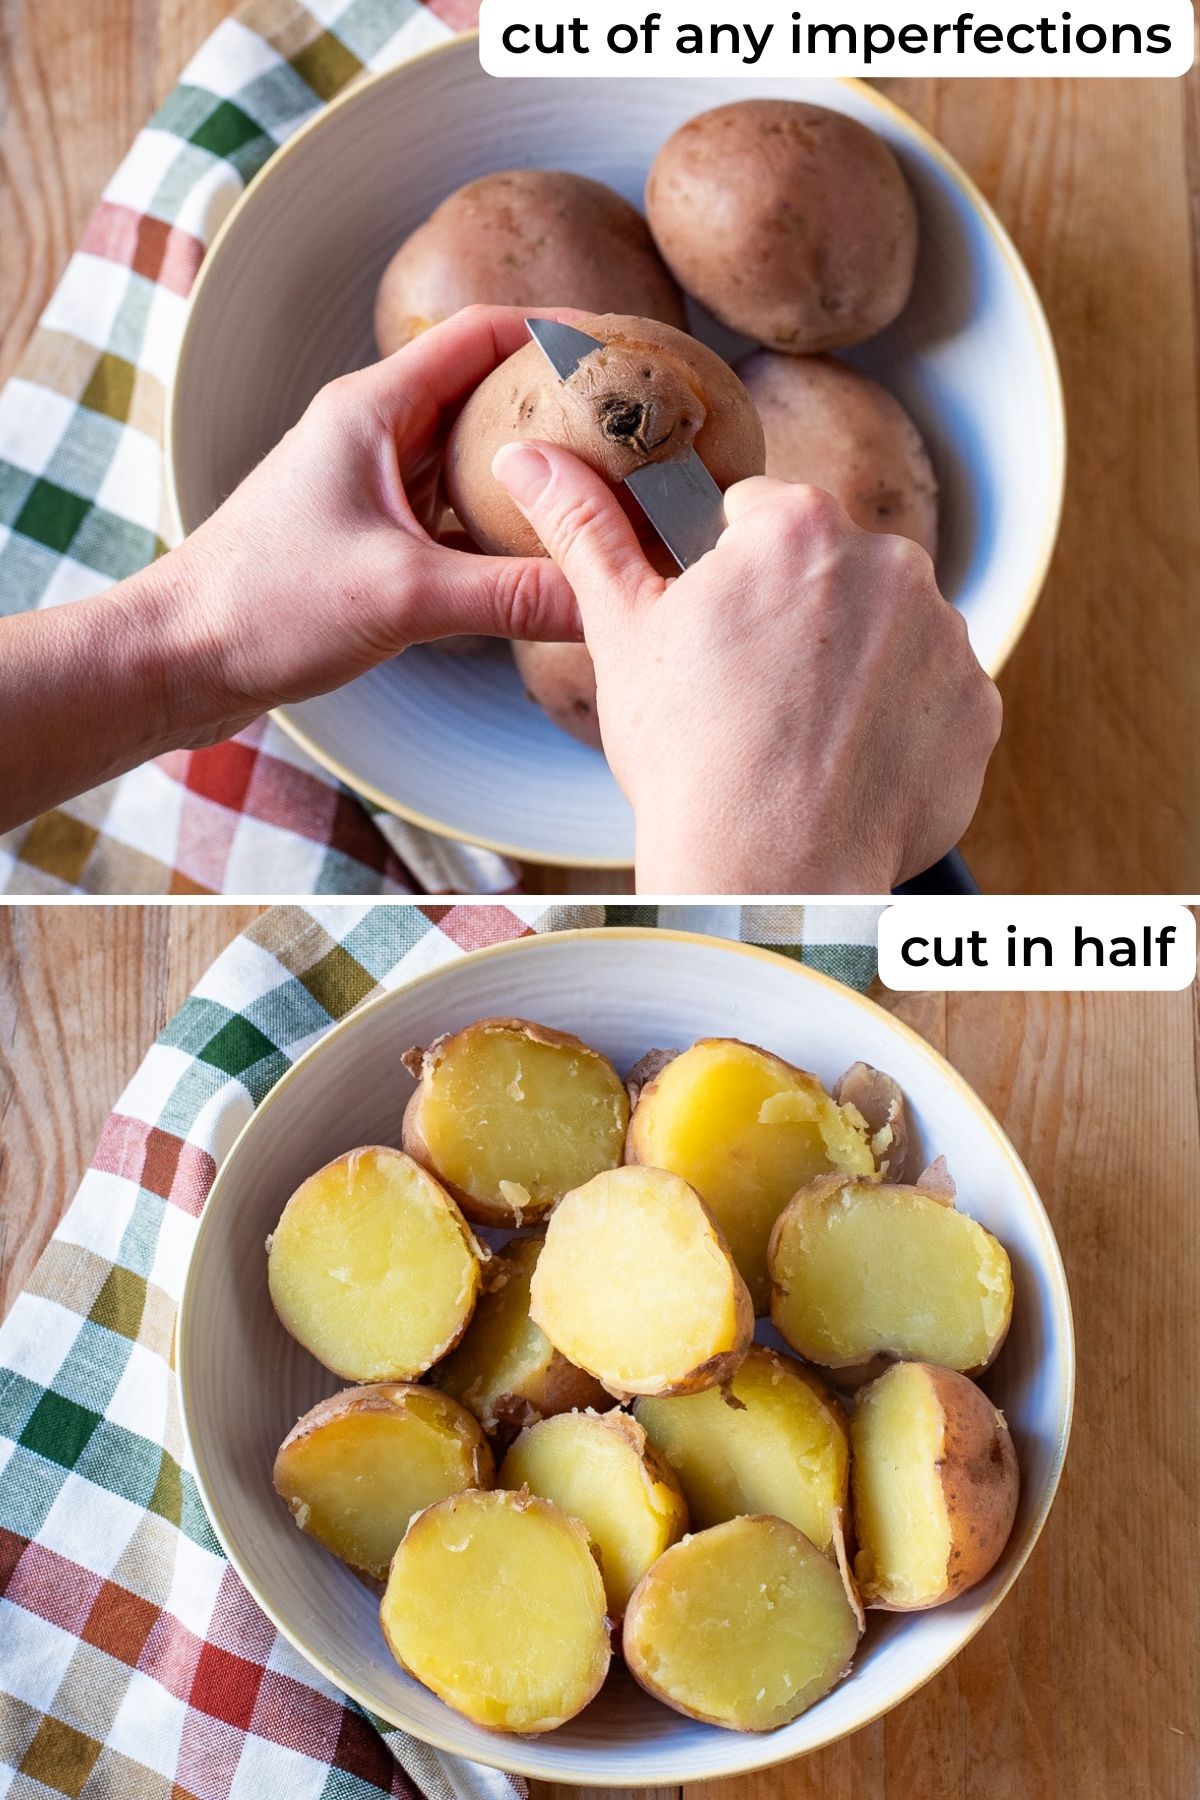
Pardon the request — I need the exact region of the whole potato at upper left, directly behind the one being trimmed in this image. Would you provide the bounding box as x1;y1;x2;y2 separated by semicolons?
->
374;169;685;356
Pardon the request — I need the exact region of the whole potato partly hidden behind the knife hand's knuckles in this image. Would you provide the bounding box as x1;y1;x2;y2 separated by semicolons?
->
738;349;937;556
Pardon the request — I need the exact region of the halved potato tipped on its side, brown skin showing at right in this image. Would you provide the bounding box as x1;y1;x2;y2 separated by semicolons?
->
851;1363;1020;1613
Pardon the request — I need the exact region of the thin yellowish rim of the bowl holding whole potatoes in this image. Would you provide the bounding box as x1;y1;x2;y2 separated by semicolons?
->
162;31;1067;869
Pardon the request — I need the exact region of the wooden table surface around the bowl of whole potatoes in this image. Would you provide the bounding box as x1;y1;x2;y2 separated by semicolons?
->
0;0;1200;893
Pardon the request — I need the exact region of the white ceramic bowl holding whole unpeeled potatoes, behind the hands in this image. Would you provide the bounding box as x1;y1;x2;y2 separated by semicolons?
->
167;36;1065;868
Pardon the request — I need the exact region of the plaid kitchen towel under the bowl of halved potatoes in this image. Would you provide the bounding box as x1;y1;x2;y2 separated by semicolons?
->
0;902;878;1800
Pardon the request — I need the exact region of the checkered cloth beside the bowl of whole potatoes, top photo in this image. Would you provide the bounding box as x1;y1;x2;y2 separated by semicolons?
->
0;0;536;895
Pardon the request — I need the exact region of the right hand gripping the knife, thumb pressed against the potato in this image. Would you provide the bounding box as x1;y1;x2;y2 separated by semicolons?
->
493;443;1000;893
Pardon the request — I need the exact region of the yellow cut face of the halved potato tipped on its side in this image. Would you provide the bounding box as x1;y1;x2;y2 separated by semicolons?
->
851;1363;952;1607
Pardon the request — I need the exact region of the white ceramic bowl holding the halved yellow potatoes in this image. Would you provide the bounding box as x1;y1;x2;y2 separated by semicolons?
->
178;931;1074;1787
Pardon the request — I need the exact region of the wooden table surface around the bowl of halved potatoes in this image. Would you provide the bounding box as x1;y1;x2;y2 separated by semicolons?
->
0;907;1200;1800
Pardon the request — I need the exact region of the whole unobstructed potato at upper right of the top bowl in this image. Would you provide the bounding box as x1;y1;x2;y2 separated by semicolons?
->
646;99;918;355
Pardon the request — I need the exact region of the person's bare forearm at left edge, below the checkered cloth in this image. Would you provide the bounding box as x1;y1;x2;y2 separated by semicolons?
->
0;551;225;830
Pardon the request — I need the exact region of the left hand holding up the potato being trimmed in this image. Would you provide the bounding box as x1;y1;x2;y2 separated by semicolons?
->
170;306;579;742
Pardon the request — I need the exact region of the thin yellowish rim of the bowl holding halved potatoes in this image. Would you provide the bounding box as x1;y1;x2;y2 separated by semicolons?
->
175;925;1076;1787
